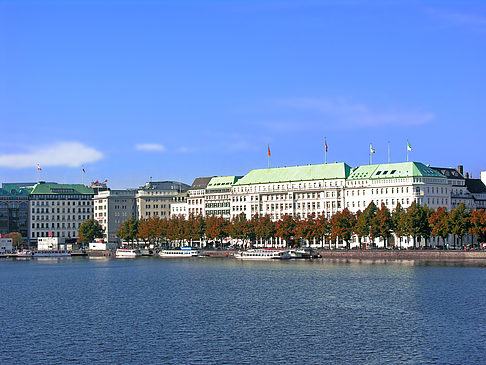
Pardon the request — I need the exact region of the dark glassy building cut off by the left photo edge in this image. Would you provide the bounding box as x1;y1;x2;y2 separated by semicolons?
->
0;184;31;239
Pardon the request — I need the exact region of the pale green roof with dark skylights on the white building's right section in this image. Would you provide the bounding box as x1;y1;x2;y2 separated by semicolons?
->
348;162;445;180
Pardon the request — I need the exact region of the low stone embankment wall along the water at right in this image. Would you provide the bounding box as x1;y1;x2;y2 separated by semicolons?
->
319;250;486;262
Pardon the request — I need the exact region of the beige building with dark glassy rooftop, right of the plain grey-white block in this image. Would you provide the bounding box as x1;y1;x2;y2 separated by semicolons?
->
136;181;189;219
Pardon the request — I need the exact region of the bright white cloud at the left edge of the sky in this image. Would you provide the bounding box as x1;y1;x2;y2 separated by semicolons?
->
0;142;103;168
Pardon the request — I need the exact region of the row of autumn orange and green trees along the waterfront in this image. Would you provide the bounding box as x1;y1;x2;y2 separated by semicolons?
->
74;202;486;249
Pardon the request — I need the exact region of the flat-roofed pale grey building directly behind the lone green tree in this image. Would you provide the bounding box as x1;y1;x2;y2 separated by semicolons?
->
93;189;137;242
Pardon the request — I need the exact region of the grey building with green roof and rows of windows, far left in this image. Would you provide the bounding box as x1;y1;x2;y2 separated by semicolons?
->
29;182;94;243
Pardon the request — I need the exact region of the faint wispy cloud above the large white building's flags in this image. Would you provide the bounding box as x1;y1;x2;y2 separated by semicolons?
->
277;98;436;129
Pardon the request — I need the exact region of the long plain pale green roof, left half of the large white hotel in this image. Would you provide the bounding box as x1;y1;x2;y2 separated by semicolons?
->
235;162;351;185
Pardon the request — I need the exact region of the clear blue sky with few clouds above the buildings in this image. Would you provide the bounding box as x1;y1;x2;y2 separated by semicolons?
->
0;0;486;188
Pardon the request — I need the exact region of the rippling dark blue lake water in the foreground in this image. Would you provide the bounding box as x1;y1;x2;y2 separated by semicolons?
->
0;258;486;364
